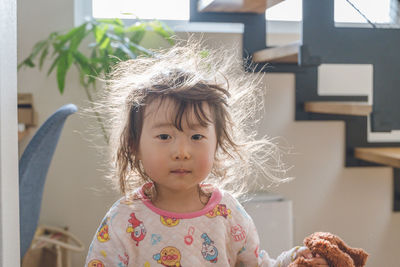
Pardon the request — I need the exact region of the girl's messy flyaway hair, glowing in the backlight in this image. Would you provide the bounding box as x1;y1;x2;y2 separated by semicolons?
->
100;40;289;200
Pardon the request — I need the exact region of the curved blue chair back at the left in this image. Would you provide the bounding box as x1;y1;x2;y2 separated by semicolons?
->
19;104;78;260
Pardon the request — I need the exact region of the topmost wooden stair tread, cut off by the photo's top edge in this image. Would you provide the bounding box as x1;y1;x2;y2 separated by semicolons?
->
198;0;284;14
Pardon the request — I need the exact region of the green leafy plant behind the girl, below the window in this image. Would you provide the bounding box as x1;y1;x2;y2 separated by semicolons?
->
18;19;174;143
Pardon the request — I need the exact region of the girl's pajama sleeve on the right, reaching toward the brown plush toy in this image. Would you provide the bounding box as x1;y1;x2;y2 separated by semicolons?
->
236;213;302;267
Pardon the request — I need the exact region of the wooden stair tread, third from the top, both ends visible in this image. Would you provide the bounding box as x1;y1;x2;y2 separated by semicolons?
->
304;101;372;116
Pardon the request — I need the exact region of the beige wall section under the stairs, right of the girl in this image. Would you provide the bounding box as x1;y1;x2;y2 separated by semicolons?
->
263;74;400;267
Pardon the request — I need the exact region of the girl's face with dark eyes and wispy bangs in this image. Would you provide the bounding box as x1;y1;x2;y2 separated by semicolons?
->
137;98;217;197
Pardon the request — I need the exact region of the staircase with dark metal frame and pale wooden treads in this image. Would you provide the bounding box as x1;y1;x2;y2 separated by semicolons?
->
191;0;400;211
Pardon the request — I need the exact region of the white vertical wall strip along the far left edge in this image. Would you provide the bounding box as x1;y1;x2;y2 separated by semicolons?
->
0;0;20;267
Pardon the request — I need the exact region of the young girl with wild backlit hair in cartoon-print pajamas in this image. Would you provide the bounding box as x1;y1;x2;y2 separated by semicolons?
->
86;40;328;267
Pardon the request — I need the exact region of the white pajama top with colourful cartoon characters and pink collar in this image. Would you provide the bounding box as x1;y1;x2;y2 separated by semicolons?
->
85;184;298;267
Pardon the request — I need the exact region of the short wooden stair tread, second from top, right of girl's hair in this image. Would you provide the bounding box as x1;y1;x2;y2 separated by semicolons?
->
253;42;301;64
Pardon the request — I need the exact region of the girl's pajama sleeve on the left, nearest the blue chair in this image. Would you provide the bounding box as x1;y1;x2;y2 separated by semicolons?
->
85;206;129;267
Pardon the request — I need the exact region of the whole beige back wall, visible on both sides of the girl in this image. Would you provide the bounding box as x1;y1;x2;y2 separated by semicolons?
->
18;0;400;267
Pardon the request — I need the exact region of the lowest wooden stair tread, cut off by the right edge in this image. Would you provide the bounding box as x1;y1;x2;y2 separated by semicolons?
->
354;147;400;168
